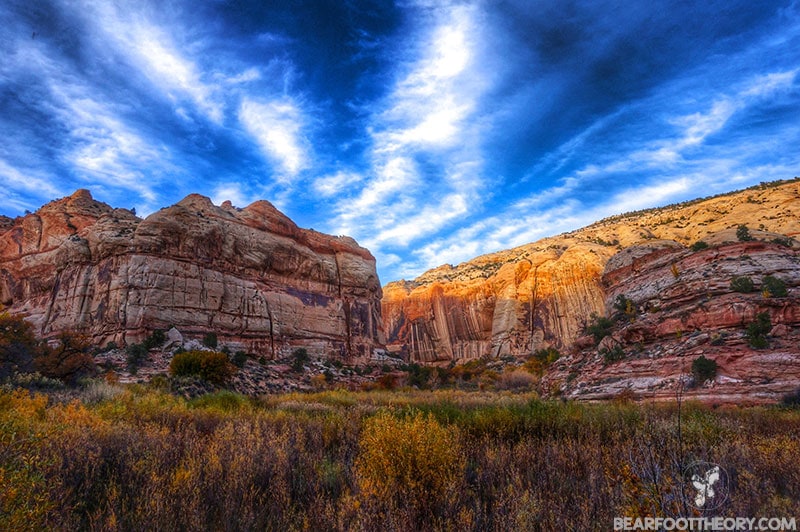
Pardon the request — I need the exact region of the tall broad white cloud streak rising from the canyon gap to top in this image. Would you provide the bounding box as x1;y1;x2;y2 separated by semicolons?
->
324;0;492;261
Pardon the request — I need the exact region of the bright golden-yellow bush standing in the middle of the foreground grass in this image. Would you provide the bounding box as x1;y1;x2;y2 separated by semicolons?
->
355;411;464;511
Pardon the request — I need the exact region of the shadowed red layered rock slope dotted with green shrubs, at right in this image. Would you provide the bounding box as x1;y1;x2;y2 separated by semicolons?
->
545;235;800;403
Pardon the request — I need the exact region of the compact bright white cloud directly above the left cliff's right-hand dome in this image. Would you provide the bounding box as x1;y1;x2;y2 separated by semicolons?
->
239;99;309;182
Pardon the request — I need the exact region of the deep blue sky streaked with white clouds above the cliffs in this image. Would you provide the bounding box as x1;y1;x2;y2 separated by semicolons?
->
0;0;800;282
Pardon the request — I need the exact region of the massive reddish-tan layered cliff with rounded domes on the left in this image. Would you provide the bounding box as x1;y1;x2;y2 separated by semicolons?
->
0;191;383;359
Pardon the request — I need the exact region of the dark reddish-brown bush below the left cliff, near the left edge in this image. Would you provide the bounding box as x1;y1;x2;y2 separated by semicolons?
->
34;332;97;384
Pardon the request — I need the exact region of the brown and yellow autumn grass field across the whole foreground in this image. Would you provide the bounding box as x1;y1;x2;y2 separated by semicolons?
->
0;382;800;531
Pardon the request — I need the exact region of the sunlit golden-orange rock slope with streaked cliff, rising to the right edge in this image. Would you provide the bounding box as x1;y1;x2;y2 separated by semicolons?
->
382;179;800;363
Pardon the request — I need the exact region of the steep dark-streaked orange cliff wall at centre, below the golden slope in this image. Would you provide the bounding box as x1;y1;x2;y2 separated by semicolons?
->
383;243;608;362
